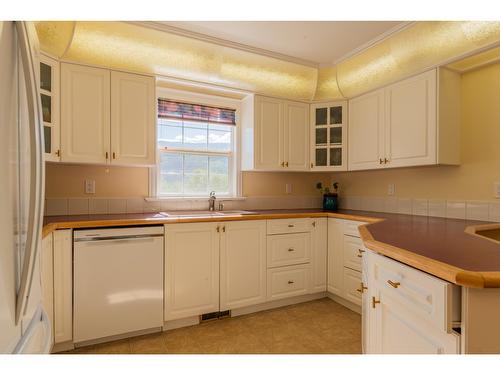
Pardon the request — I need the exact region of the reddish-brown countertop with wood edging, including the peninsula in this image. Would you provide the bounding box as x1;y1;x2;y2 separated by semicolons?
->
43;209;500;288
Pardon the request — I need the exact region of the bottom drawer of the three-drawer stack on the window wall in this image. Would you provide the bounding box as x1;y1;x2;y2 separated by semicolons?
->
267;265;311;300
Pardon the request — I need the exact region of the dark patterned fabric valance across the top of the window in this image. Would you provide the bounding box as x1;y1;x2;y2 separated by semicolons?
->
158;98;236;125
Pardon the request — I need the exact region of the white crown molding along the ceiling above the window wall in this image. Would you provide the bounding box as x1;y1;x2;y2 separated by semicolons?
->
123;21;319;69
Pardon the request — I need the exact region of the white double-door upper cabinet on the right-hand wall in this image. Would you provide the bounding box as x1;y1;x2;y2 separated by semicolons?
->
349;69;460;170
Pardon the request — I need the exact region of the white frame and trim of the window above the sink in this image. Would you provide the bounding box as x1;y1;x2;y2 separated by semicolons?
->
149;87;241;200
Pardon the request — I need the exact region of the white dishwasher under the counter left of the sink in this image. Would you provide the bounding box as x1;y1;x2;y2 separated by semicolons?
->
73;226;164;343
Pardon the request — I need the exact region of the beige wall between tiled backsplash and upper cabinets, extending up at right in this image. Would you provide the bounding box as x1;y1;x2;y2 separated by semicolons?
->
46;64;500;199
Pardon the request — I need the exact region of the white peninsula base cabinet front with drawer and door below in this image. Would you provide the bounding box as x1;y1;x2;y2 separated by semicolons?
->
362;251;460;354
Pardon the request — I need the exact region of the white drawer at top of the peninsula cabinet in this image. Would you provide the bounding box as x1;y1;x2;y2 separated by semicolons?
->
368;252;459;332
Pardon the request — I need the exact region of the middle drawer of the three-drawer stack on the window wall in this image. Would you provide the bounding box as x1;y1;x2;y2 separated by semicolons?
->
267;233;311;268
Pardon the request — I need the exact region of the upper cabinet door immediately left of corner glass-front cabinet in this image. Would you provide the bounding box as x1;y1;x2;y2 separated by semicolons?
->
284;101;309;171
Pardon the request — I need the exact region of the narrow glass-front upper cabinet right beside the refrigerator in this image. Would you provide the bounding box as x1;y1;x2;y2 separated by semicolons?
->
40;54;61;161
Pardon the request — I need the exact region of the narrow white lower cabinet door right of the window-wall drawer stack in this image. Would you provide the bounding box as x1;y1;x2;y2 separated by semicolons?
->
311;218;328;292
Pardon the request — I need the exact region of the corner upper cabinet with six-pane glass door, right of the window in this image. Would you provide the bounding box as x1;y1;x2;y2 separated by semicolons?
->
311;101;347;171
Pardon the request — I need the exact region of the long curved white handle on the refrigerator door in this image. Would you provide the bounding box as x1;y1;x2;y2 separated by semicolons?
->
15;21;44;324
